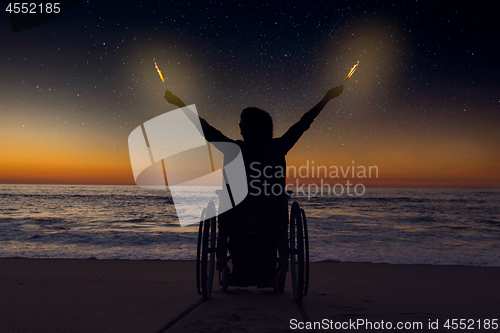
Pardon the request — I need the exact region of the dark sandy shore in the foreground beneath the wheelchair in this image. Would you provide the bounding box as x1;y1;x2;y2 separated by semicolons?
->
0;259;500;332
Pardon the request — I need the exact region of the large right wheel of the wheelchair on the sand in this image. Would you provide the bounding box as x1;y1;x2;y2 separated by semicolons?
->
290;202;309;304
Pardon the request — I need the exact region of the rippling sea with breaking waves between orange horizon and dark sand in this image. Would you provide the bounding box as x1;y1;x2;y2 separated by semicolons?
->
0;185;500;266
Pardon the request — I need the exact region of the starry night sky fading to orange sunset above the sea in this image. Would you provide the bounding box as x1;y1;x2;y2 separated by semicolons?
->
0;0;500;187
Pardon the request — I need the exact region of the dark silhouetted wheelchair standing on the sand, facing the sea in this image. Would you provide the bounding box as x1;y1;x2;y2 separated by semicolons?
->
196;191;309;304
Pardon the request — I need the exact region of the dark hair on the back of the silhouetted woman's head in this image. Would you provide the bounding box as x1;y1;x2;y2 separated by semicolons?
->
240;107;273;141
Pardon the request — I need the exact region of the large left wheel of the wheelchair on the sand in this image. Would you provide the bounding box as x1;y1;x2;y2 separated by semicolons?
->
200;201;217;300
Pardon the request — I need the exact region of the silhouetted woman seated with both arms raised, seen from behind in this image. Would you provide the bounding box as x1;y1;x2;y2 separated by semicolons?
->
165;86;344;287
